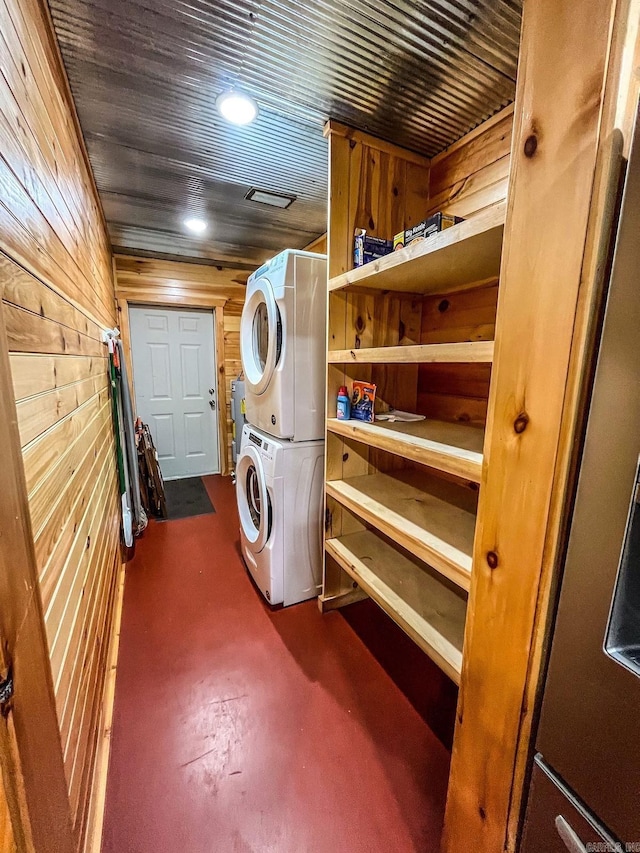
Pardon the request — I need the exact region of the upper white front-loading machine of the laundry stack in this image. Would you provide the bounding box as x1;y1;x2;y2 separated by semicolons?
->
240;249;327;441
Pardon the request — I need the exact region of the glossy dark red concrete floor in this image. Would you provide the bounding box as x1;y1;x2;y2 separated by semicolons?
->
103;477;455;853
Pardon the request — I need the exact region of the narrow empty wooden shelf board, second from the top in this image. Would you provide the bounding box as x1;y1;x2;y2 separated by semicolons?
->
328;341;493;364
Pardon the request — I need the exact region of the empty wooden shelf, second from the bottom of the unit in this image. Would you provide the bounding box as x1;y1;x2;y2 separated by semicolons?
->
327;471;476;591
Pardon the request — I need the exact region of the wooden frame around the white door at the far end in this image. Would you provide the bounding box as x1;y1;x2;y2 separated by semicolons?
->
117;295;229;476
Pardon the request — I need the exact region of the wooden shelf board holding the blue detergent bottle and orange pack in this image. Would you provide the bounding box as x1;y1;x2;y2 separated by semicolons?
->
327;418;484;483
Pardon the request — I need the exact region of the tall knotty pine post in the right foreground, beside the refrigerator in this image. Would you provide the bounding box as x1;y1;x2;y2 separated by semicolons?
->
443;0;616;853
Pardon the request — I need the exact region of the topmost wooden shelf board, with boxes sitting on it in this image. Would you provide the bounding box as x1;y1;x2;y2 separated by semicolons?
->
329;202;506;293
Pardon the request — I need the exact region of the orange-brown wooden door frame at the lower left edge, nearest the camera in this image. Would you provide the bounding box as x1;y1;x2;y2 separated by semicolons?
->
0;292;76;853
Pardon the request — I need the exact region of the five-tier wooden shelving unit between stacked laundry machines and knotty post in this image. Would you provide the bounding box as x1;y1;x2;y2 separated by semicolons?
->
319;120;506;683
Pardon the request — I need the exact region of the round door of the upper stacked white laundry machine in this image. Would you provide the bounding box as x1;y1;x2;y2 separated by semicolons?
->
240;278;282;394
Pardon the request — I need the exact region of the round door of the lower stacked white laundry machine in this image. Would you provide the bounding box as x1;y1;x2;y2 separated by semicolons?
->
236;445;272;553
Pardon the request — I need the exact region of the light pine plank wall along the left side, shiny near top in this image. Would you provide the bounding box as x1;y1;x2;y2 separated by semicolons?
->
0;0;120;845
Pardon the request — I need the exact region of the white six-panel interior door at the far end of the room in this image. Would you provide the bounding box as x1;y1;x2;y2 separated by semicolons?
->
129;306;220;480
